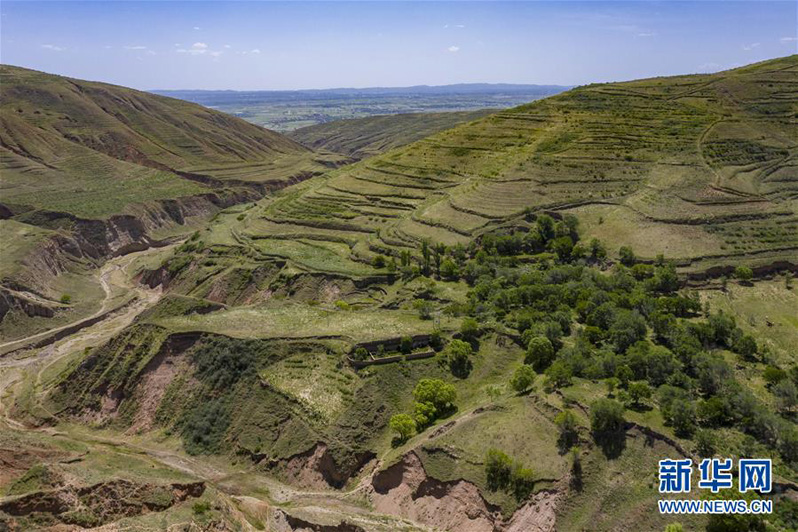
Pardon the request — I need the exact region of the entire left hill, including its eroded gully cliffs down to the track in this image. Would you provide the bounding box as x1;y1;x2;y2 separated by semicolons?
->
0;65;346;339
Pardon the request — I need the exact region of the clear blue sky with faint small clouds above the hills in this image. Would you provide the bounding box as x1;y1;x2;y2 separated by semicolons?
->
0;1;798;90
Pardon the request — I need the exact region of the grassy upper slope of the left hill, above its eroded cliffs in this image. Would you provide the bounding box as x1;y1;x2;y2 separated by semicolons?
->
0;65;340;218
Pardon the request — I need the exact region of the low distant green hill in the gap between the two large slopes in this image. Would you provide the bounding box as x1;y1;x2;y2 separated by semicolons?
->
287;109;496;159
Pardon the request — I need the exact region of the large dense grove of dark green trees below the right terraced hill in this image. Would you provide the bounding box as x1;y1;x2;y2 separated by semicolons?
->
412;215;798;463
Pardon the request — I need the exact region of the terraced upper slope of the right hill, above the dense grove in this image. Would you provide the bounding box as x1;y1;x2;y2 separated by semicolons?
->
258;56;798;276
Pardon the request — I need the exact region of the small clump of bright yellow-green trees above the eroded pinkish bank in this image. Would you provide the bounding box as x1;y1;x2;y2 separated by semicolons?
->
389;379;457;442
